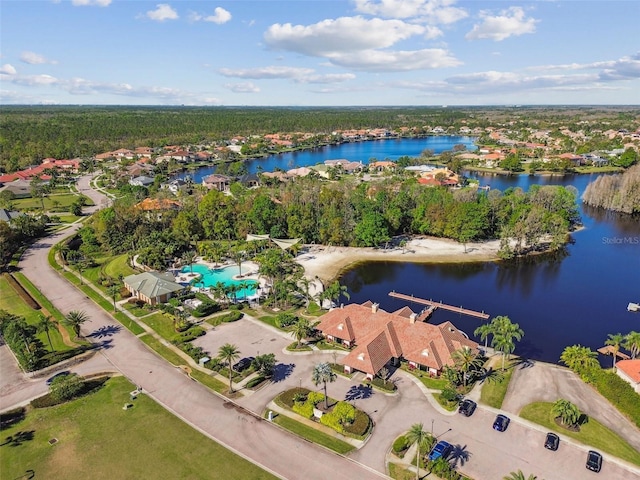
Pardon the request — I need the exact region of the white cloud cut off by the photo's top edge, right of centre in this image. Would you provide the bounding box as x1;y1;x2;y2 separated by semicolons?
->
355;0;468;24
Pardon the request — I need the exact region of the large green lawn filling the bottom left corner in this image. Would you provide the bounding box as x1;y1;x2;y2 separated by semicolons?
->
0;377;275;480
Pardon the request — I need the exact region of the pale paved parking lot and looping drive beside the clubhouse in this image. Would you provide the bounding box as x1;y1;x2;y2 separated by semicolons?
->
194;318;640;480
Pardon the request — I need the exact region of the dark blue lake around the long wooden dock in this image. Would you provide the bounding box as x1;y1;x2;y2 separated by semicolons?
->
341;171;640;366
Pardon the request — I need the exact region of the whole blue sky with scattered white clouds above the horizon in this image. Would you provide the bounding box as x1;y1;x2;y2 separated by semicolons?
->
0;0;640;106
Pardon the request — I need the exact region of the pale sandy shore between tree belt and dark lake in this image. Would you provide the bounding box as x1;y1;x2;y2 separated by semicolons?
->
296;237;500;282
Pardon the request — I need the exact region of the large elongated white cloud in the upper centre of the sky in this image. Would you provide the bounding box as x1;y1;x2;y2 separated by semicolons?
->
264;16;425;56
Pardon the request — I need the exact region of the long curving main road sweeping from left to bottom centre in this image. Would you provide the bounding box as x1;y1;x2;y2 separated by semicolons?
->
10;182;385;480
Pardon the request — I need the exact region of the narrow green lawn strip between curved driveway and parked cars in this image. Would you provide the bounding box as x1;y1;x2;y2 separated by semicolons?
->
520;402;640;465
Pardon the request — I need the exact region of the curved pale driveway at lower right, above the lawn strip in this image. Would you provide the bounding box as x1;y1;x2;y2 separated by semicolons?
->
502;362;640;451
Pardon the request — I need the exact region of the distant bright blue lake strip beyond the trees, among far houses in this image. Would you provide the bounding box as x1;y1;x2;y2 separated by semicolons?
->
177;135;476;183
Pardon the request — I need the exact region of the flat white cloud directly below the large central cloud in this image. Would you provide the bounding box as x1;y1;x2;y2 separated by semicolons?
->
331;48;462;72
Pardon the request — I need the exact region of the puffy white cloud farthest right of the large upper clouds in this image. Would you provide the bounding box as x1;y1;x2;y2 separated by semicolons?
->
465;7;538;42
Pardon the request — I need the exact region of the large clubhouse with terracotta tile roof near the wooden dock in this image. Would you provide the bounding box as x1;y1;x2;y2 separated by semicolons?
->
316;301;478;379
